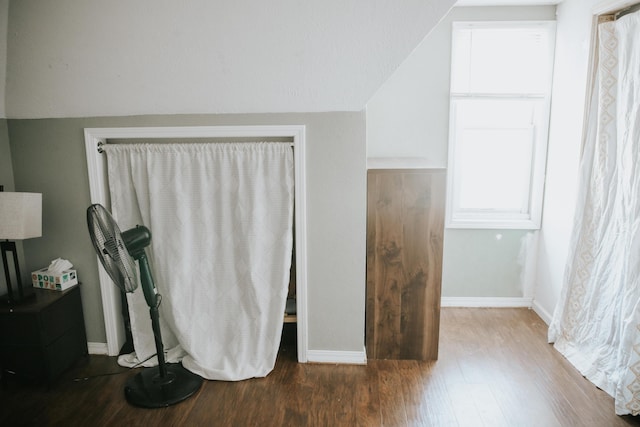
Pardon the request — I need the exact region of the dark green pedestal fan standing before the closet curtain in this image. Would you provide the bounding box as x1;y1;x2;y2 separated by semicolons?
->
87;204;202;408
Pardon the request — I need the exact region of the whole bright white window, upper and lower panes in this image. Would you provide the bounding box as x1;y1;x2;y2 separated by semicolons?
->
447;22;555;229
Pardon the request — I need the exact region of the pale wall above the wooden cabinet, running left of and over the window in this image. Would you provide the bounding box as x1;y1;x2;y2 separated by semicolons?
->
367;6;555;167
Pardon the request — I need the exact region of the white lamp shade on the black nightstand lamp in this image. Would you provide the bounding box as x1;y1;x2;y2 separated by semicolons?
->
0;192;42;240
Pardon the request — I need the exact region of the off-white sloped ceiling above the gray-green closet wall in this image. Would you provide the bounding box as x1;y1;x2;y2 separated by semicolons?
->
5;0;455;118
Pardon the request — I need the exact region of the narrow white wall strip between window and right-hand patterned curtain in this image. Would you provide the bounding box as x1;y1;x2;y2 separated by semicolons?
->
534;0;614;322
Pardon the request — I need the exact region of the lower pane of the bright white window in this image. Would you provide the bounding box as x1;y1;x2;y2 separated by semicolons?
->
453;98;542;213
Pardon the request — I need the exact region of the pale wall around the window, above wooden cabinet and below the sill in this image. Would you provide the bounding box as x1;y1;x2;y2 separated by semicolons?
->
367;6;555;303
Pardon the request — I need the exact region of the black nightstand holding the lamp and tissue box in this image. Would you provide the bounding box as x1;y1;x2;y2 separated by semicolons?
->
0;285;88;385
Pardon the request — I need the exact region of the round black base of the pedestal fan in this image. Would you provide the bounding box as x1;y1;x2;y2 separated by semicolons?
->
124;363;202;408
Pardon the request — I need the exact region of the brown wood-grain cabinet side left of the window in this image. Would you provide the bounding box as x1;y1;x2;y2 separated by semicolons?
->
366;169;446;360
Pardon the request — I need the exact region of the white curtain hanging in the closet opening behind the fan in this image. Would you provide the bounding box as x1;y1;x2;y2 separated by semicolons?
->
105;142;294;381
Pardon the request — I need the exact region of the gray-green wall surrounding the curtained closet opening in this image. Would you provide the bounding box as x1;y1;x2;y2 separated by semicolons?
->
6;112;366;351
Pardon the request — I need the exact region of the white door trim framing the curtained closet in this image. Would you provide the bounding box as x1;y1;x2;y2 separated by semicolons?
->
84;125;308;363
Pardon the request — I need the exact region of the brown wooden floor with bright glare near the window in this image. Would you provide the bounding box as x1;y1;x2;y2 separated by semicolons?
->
0;308;640;427
